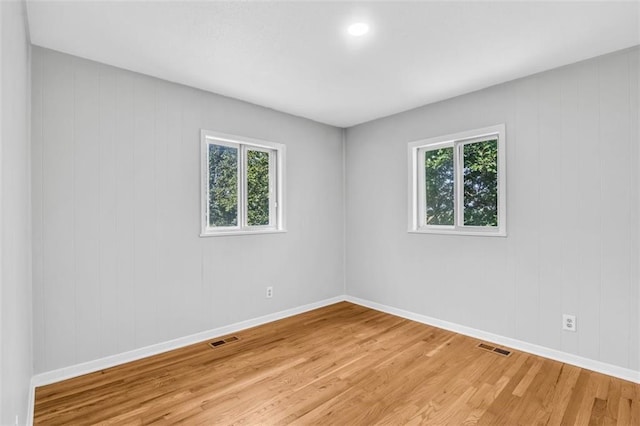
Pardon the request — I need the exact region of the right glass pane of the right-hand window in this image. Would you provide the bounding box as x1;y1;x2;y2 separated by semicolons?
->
463;139;498;226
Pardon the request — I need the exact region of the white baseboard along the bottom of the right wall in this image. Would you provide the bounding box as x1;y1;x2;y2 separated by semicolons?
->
345;296;640;383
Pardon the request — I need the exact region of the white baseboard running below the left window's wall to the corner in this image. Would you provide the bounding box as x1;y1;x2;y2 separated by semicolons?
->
31;296;345;390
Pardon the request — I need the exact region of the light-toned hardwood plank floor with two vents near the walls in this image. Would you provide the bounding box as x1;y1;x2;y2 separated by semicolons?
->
35;302;640;426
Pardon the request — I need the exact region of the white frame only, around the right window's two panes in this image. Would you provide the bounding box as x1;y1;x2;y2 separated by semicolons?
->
408;124;507;237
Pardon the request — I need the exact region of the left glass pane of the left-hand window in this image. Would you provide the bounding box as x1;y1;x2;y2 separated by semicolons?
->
209;144;238;226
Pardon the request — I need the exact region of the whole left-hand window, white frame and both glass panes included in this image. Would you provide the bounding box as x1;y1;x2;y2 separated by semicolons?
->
201;130;285;236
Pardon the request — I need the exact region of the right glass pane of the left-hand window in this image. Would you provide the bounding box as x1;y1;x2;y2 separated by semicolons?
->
247;150;269;226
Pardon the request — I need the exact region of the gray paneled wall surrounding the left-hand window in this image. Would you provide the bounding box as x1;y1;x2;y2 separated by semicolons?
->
32;47;344;372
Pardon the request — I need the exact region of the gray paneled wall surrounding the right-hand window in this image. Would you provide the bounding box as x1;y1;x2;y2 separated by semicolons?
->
346;48;640;370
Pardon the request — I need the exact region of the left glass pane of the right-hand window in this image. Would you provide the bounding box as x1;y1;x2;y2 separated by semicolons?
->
424;147;454;225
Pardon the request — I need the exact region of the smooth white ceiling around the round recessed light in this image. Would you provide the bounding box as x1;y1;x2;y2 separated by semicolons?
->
27;0;640;127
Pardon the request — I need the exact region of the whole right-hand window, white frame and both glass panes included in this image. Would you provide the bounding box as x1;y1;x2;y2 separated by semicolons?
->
409;124;506;236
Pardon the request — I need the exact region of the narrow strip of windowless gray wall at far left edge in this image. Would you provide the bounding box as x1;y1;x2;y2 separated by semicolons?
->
0;2;33;425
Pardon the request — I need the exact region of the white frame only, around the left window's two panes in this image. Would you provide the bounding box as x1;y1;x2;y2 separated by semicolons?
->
200;129;286;237
